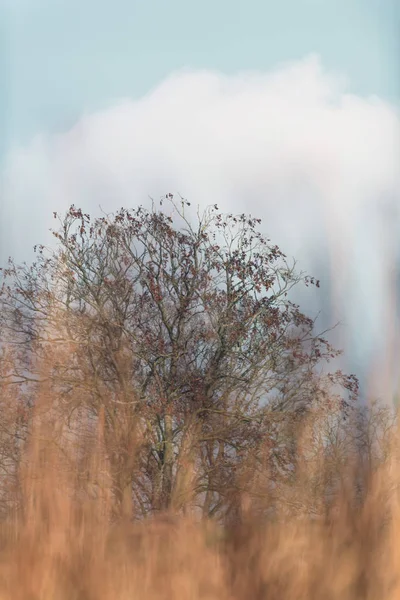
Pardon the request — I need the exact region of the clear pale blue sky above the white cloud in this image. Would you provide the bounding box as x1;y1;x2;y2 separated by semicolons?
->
0;0;400;151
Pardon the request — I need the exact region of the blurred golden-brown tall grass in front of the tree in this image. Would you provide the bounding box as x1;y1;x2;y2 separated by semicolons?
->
0;370;400;600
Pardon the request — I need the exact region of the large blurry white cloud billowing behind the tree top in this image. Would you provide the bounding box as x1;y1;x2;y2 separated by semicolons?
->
3;57;400;394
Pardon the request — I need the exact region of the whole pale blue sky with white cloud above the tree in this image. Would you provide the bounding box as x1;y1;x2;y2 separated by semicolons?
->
0;0;400;398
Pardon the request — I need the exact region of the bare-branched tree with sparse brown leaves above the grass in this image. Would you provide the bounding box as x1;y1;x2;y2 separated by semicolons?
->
0;194;357;516
